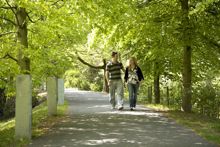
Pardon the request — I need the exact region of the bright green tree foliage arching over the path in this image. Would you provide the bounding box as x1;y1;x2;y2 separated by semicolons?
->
0;0;220;116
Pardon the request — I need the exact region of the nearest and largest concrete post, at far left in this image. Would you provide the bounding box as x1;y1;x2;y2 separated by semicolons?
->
15;75;32;139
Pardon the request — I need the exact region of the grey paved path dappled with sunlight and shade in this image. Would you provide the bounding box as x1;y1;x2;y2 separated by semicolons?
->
30;90;218;147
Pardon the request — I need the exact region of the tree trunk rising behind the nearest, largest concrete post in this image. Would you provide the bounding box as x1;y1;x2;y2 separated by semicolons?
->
16;8;30;73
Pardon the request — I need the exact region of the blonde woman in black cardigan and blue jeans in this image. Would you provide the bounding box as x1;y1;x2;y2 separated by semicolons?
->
124;57;144;111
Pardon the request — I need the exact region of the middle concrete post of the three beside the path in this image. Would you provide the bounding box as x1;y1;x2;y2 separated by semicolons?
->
47;77;58;116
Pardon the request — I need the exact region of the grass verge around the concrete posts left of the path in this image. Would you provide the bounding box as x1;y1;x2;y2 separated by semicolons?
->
0;102;68;147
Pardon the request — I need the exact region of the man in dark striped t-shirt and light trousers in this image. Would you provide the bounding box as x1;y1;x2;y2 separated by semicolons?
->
106;52;124;110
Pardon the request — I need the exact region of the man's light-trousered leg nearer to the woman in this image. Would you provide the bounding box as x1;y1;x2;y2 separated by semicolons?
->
116;80;124;110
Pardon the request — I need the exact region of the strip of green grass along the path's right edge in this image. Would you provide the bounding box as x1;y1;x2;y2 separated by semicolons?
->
146;105;220;145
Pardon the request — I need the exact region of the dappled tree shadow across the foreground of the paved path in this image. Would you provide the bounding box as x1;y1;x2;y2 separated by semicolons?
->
29;114;217;147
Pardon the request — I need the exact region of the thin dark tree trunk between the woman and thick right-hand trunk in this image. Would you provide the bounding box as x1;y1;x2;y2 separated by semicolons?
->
154;62;160;104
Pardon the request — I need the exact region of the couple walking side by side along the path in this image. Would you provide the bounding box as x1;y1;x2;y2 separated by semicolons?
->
106;52;144;110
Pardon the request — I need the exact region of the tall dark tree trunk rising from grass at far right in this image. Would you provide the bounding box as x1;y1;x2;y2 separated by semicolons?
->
181;0;192;112
